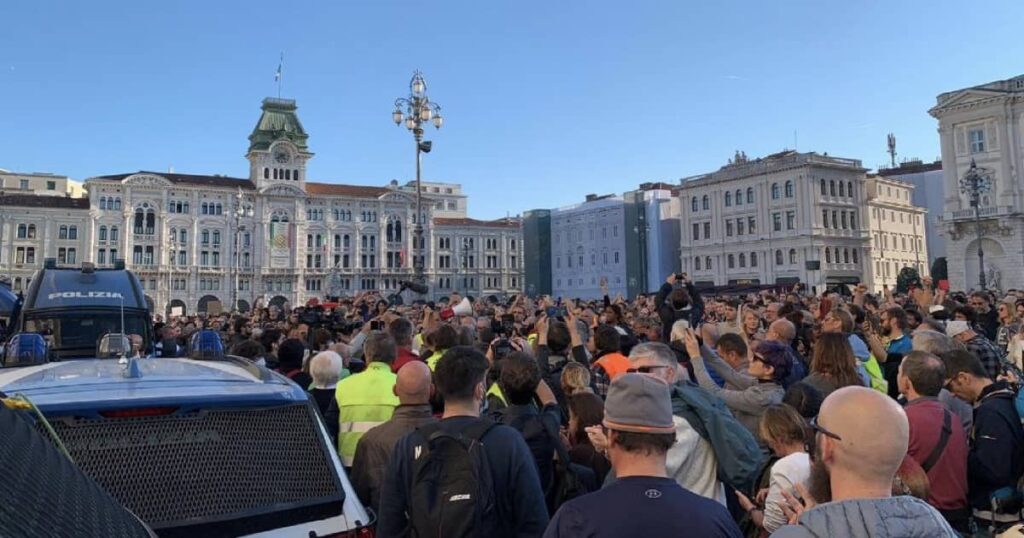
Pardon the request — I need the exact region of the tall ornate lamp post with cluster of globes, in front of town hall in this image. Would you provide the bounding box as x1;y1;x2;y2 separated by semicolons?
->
391;71;444;284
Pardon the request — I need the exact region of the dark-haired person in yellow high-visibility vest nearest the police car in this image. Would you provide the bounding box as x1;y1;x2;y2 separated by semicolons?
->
335;332;398;467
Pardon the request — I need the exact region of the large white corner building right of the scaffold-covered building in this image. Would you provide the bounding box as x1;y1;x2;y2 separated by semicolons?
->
679;151;871;291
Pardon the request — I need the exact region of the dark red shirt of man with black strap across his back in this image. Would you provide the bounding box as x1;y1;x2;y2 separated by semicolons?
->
904;398;968;510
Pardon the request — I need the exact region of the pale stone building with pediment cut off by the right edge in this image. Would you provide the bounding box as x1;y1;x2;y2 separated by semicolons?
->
928;76;1024;290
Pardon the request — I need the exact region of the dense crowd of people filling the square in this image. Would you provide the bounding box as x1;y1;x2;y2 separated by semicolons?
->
149;274;1024;537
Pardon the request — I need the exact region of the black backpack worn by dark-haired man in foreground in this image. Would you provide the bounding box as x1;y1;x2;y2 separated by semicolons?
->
409;419;500;538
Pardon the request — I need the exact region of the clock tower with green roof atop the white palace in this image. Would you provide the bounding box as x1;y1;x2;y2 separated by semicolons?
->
246;97;313;191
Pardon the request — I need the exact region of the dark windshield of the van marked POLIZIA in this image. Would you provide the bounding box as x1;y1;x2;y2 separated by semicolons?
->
25;312;150;359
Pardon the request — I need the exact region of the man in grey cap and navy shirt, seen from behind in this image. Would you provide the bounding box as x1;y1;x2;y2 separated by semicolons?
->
544;373;741;538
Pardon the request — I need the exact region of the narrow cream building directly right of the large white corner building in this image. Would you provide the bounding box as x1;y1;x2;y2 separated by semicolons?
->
867;175;929;291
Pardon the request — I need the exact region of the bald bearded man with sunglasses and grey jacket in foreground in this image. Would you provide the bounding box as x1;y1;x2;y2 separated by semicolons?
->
772;386;958;538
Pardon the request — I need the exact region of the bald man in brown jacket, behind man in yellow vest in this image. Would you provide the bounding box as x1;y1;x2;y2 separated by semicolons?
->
349;361;437;512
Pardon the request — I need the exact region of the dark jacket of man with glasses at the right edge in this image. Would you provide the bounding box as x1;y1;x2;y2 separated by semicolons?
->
967;381;1024;509
